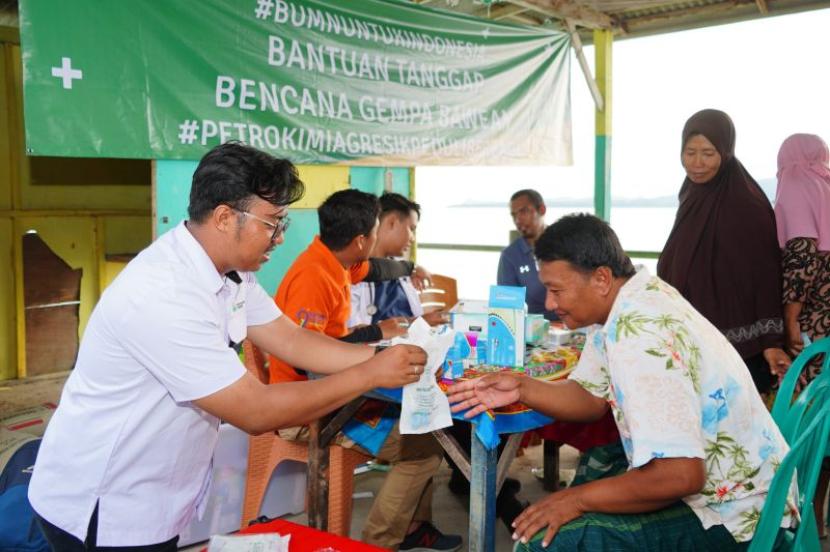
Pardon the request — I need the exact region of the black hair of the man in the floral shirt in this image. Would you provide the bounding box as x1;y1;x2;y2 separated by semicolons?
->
535;213;635;278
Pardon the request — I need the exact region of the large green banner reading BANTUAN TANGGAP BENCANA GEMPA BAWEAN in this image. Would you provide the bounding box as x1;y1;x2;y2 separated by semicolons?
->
20;0;571;166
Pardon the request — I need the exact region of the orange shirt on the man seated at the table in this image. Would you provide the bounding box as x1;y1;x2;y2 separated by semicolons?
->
269;236;369;383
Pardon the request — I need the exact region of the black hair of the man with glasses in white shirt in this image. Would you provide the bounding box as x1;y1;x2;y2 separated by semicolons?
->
187;142;305;223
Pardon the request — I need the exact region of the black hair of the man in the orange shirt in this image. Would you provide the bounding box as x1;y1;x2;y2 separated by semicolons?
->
317;189;380;251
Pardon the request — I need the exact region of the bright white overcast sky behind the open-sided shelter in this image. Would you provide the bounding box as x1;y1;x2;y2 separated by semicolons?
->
416;5;830;204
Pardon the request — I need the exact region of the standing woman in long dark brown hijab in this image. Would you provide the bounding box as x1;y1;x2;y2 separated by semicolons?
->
657;109;790;393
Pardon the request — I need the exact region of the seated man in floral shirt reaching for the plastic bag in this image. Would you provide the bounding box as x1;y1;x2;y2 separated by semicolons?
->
450;215;791;552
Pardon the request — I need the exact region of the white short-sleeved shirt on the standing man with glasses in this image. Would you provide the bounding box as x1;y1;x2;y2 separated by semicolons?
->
29;223;281;546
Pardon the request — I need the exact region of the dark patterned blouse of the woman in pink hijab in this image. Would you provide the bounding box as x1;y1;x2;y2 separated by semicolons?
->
783;238;830;379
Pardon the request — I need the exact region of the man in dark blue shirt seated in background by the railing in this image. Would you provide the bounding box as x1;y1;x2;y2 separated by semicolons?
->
496;189;558;320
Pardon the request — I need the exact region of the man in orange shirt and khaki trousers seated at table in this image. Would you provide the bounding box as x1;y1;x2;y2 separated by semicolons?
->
270;189;462;551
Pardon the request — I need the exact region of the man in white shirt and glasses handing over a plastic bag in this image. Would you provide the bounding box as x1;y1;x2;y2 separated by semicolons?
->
29;143;426;552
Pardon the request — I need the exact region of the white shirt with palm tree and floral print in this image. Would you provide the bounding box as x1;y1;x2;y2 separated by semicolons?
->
571;269;795;542
